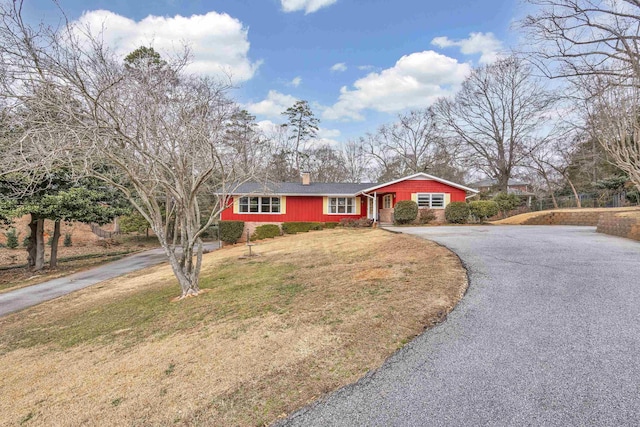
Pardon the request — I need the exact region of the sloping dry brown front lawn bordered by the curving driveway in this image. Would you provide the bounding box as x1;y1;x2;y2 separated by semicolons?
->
0;230;466;425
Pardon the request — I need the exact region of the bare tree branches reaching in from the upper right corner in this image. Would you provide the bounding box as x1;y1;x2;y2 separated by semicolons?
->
522;0;640;189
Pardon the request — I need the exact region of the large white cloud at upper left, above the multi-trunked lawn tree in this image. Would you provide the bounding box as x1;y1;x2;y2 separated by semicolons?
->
74;10;261;83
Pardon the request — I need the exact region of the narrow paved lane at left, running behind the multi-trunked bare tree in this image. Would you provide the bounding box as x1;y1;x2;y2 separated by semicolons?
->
0;243;218;316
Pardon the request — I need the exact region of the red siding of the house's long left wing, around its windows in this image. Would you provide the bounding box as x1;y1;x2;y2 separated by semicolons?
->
220;196;367;222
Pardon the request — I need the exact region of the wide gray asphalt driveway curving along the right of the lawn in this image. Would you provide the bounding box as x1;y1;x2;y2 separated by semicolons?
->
282;226;640;426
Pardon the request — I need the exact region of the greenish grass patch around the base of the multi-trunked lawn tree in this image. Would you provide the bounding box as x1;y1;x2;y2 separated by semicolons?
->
0;261;304;353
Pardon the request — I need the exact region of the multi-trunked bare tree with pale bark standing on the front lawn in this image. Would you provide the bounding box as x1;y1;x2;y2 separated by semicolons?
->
0;3;255;297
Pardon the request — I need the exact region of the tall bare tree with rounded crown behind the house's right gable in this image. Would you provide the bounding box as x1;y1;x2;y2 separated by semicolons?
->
435;56;554;191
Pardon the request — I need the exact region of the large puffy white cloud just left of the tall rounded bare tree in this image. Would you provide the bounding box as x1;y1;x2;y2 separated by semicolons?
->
322;50;471;120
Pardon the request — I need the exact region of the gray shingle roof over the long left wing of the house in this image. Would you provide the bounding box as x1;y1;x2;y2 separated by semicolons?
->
233;182;376;196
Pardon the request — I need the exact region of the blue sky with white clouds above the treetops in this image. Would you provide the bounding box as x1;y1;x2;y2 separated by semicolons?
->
25;0;520;144
